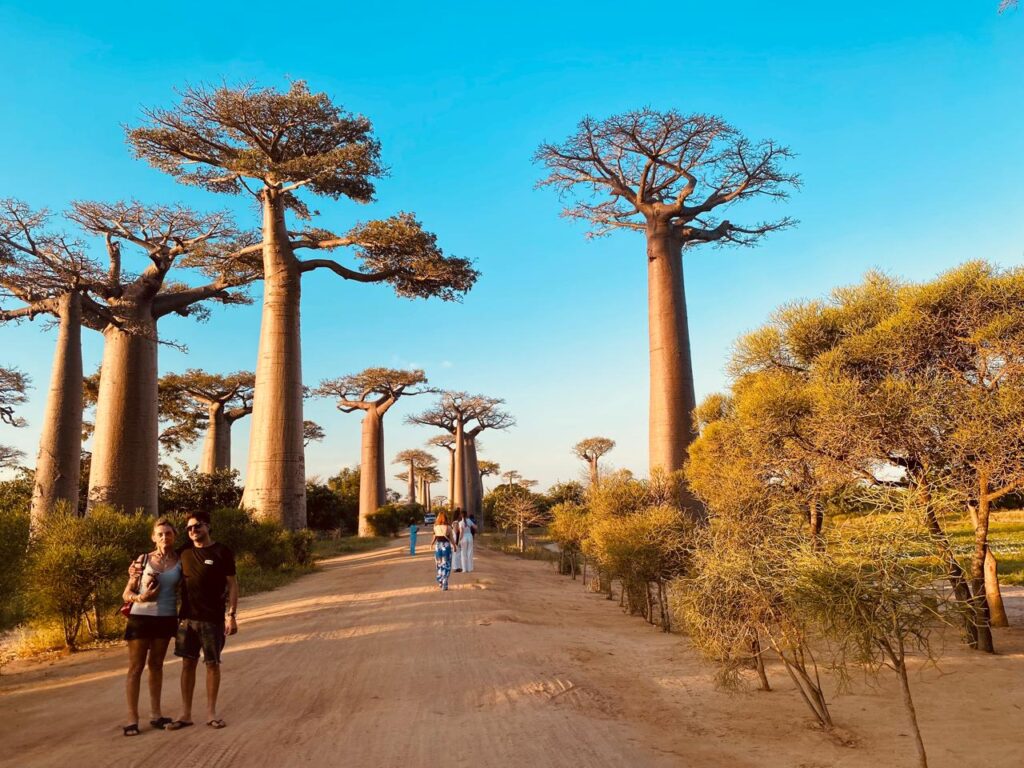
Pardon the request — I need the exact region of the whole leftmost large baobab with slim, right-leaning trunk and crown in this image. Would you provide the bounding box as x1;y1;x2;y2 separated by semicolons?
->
0;199;113;524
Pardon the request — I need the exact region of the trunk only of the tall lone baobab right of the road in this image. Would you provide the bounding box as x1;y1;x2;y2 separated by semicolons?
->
647;230;696;472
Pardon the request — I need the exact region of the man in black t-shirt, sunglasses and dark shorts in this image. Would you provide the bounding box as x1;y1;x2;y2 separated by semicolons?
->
167;512;239;731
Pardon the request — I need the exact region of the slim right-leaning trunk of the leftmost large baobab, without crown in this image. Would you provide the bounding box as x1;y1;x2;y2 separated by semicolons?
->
32;292;82;527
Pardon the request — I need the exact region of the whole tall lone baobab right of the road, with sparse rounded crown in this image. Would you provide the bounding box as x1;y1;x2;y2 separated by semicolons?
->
535;108;800;472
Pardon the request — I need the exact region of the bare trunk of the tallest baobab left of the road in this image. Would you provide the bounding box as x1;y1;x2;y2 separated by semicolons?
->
242;189;306;530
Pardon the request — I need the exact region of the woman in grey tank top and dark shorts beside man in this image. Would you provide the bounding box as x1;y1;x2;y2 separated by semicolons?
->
123;517;181;736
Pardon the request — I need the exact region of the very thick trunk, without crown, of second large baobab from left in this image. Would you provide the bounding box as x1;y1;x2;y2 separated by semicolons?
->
89;311;160;515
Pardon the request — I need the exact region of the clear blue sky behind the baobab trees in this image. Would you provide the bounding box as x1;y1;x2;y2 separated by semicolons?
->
0;0;1024;493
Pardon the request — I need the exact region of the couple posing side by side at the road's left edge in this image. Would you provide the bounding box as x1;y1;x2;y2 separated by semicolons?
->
124;512;239;736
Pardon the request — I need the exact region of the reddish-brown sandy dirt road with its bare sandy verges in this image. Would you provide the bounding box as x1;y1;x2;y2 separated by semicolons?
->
0;542;1024;768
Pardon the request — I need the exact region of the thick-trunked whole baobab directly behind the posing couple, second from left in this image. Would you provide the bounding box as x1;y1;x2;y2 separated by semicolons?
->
69;202;251;514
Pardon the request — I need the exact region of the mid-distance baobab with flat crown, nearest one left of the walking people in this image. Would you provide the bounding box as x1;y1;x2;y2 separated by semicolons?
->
313;368;436;536
